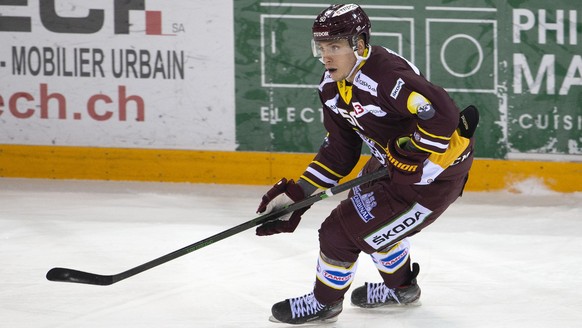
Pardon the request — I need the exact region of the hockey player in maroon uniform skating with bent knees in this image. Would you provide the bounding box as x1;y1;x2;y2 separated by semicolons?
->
256;4;478;324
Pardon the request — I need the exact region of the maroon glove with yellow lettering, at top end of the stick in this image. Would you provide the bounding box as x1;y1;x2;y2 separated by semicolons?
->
386;137;429;185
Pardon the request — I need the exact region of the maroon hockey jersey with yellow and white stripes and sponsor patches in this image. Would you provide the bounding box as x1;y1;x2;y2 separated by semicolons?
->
301;46;472;188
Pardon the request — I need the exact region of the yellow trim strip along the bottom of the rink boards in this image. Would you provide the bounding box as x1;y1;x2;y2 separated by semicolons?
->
0;145;582;192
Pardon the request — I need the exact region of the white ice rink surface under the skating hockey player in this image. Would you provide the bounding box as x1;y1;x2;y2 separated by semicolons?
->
0;179;582;328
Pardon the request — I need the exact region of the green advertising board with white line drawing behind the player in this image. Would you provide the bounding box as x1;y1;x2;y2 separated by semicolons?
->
234;0;582;161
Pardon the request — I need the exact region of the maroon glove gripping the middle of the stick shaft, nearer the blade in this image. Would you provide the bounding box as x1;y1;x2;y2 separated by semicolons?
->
257;178;310;236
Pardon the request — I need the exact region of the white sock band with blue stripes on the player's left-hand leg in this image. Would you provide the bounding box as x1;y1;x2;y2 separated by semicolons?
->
317;252;358;290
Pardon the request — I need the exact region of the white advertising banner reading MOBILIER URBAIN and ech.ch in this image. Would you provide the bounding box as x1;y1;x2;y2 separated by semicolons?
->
0;0;235;150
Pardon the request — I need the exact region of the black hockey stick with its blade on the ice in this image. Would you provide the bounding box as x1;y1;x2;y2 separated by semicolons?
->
46;168;388;286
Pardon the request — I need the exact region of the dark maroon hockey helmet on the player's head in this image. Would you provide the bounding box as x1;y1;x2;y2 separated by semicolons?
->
312;4;372;46
